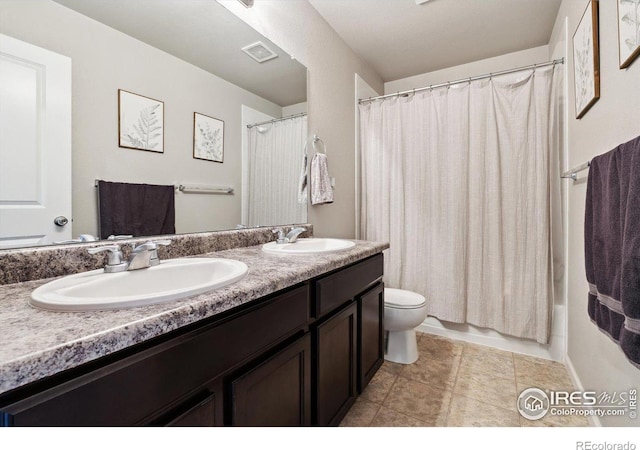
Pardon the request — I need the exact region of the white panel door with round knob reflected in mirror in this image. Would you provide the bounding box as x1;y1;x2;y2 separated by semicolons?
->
0;34;71;248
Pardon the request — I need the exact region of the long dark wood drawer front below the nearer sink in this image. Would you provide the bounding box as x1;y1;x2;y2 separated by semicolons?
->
0;285;309;426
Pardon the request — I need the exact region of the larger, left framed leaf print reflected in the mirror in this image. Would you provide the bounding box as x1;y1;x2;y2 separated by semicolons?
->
118;89;164;153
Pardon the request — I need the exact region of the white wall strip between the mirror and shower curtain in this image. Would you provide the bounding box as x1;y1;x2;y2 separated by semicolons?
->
219;0;382;238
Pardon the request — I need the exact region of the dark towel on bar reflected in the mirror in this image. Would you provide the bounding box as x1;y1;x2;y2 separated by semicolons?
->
98;180;176;239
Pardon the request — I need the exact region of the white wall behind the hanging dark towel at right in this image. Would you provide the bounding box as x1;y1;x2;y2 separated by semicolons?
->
549;0;640;426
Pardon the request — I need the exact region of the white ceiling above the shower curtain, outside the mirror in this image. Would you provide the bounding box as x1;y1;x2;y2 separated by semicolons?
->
309;0;561;82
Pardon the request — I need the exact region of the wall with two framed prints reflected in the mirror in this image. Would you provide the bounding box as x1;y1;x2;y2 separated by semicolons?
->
0;0;282;236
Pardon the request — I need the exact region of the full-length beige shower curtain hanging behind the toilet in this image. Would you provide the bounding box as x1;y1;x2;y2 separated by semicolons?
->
360;66;562;343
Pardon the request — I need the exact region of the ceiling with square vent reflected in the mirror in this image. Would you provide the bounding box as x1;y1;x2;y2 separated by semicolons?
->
55;0;307;106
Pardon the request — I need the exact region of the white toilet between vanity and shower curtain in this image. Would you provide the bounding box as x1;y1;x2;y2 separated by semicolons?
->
384;288;427;364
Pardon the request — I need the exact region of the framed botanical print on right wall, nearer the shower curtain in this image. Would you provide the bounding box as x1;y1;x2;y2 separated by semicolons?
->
573;0;600;119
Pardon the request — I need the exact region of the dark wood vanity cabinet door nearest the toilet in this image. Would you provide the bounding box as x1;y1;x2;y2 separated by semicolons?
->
358;283;384;393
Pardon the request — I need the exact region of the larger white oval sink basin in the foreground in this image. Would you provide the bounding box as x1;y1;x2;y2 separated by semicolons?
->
30;258;249;311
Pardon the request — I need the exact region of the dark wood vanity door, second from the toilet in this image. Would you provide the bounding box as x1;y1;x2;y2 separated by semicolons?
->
314;302;358;426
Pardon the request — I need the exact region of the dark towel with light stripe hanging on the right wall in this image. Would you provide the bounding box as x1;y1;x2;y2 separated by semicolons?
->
585;136;640;368
